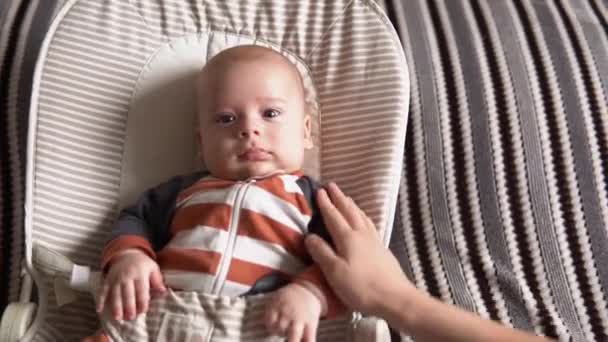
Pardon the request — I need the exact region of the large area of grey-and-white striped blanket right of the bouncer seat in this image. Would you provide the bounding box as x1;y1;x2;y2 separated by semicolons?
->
388;0;608;341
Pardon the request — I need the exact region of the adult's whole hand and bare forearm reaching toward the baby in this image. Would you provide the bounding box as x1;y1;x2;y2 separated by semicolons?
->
306;184;549;342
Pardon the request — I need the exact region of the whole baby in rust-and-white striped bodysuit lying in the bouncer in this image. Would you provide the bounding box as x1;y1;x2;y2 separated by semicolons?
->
97;46;342;341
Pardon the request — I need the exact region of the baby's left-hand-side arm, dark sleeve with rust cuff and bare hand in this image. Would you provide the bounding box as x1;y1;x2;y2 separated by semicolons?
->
97;173;202;319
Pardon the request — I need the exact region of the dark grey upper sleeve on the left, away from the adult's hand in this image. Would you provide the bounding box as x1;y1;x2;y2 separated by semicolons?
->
109;172;205;251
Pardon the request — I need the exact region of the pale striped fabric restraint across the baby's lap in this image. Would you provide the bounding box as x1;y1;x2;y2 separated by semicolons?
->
102;291;354;342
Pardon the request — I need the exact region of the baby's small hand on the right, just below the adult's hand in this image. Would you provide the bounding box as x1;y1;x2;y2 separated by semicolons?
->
265;283;323;342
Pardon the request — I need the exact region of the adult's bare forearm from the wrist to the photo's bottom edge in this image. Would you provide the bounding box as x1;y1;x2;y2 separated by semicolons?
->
385;291;551;342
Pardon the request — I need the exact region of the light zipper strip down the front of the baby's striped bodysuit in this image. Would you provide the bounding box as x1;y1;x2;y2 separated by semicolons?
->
211;179;255;295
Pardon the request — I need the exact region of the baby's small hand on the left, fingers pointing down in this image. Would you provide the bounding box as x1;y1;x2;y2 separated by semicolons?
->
97;249;165;320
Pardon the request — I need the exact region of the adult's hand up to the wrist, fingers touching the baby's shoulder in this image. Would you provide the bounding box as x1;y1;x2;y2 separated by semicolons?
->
305;183;414;316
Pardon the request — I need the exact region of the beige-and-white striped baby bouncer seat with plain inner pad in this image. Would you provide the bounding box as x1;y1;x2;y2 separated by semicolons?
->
0;0;409;341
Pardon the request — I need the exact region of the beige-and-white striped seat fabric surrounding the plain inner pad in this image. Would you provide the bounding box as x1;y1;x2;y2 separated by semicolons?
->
21;0;409;341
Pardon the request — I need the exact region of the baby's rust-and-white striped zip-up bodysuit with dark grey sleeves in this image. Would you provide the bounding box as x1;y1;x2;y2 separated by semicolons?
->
102;171;341;316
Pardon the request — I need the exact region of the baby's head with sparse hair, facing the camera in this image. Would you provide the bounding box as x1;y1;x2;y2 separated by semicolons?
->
197;45;312;180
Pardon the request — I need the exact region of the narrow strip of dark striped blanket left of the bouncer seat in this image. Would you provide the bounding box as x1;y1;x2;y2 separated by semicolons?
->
0;0;63;312
